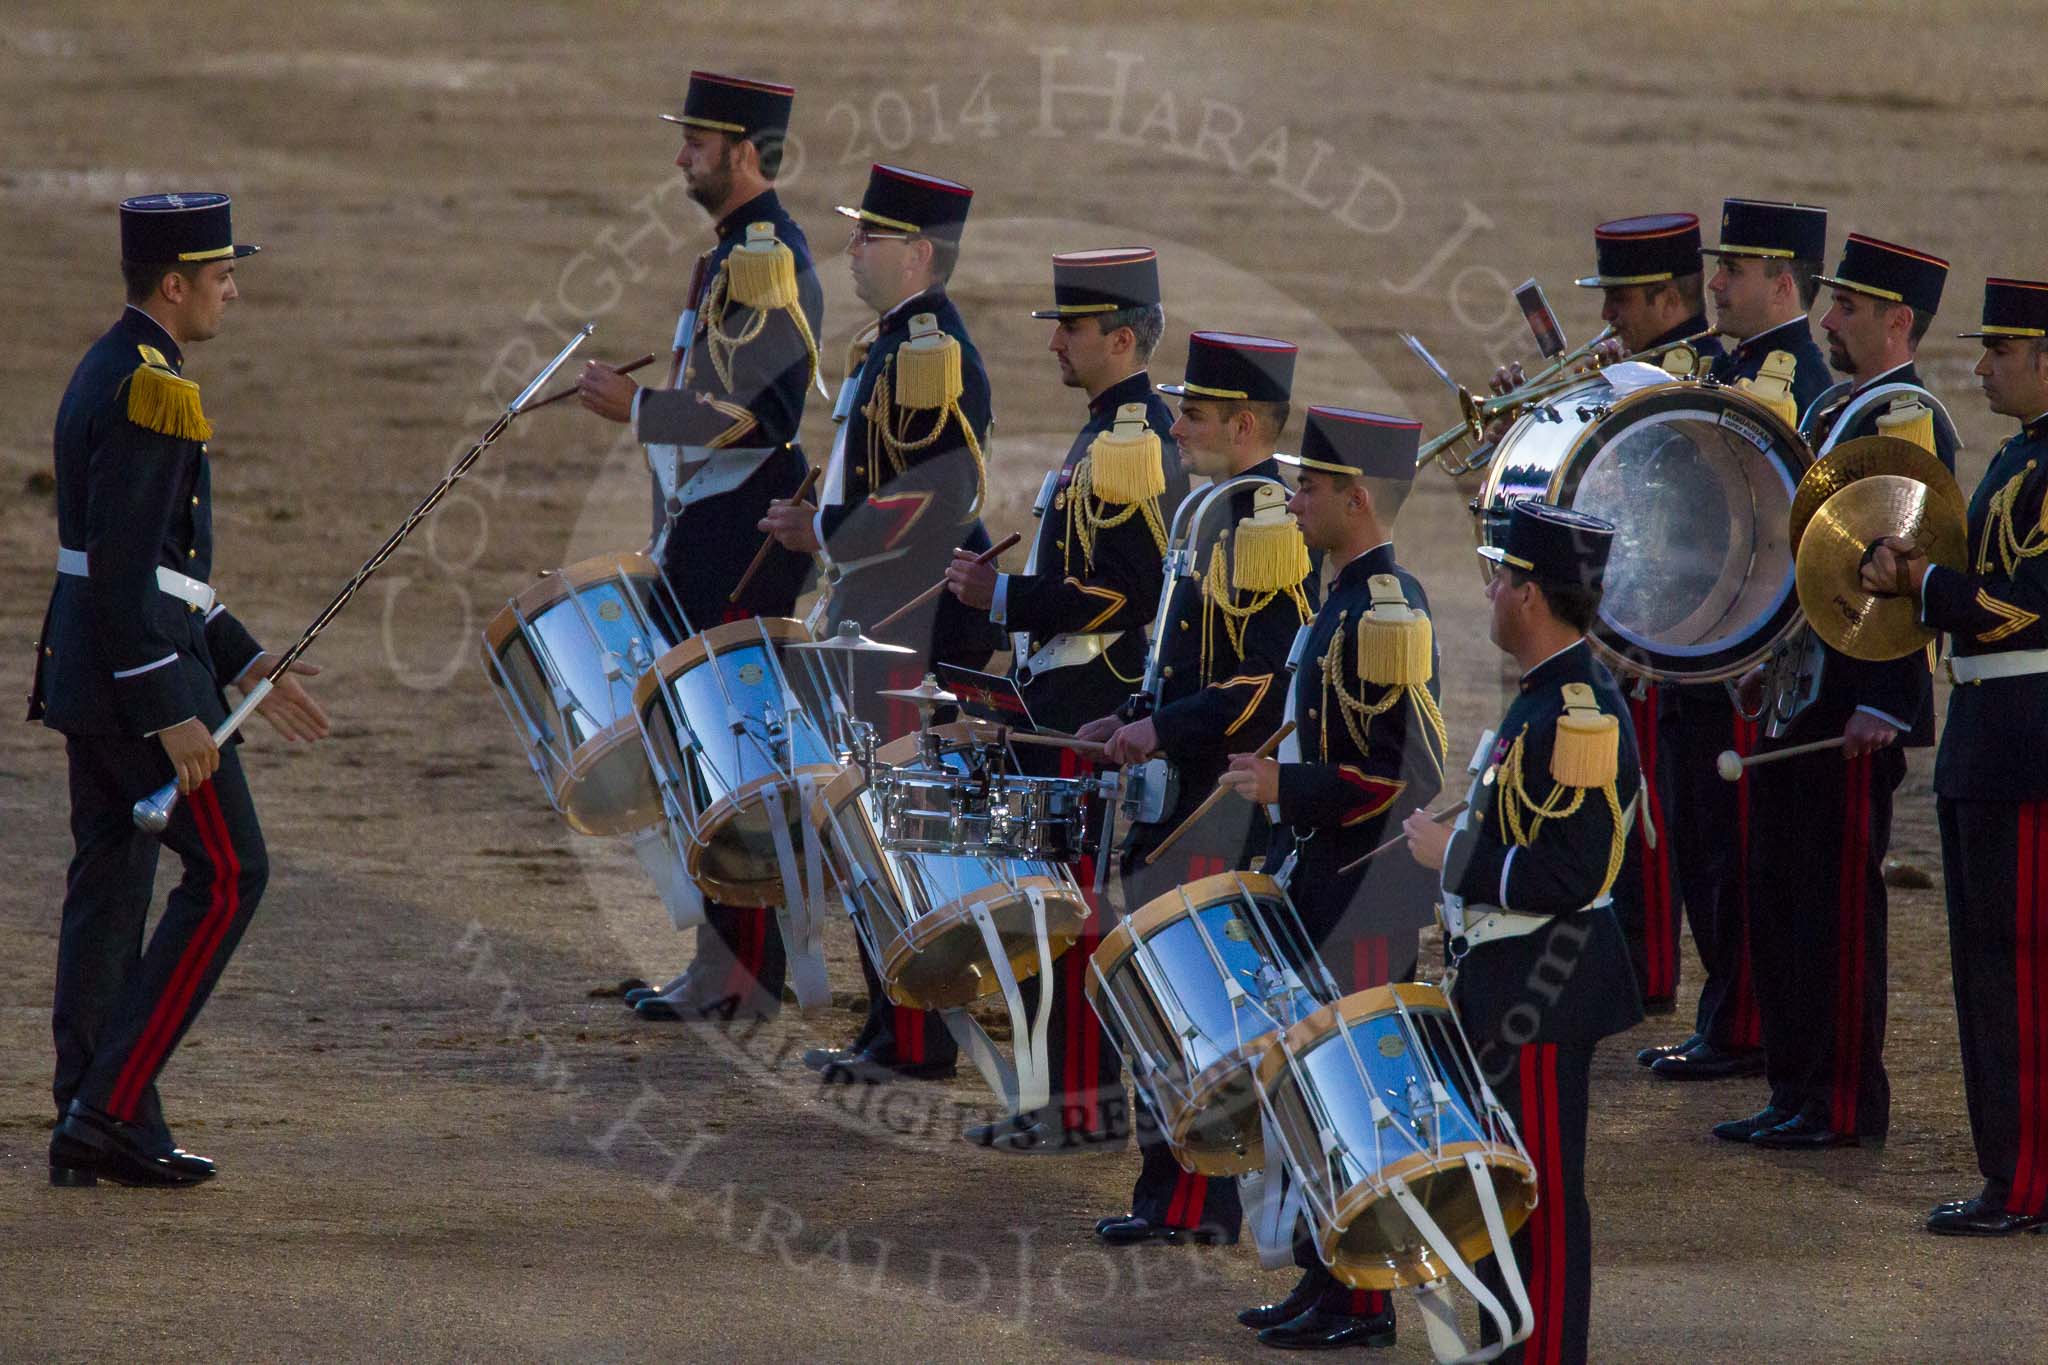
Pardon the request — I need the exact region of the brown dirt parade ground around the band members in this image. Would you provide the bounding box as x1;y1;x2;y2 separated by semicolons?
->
0;0;2048;1363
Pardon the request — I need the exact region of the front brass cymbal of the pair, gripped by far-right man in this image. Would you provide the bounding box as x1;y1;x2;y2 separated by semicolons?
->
1796;474;1968;663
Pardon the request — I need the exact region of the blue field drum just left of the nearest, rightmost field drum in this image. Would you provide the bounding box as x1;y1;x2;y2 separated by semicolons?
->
1087;872;1319;1175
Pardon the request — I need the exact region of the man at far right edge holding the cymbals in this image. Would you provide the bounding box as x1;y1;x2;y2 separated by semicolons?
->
1864;278;2048;1236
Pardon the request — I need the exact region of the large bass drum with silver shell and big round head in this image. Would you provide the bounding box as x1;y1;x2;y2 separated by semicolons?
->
1473;362;1812;681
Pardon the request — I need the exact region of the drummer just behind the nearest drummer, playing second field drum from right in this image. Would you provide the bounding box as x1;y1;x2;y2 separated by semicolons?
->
1223;407;1446;1349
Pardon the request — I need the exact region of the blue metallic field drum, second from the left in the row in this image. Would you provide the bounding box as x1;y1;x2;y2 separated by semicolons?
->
633;616;840;907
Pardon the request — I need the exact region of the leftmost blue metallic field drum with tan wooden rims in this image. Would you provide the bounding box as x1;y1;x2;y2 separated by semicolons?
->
483;551;680;835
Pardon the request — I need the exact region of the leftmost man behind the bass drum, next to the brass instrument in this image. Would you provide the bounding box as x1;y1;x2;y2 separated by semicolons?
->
1579;213;1722;1015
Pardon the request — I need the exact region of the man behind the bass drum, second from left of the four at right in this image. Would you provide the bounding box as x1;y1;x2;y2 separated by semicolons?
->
1636;199;1829;1081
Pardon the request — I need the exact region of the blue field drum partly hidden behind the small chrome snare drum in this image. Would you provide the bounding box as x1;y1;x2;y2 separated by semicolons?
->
825;724;1087;1009
